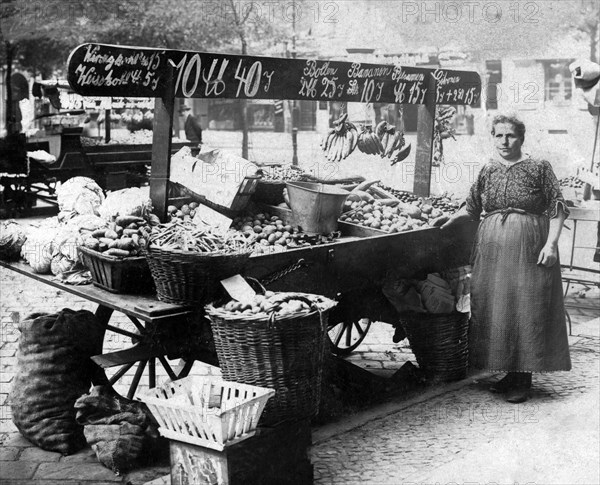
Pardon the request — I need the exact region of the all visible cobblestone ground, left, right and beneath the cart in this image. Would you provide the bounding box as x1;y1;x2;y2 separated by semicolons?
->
0;260;600;485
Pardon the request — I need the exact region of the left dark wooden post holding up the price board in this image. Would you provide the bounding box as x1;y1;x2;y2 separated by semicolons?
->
150;62;175;222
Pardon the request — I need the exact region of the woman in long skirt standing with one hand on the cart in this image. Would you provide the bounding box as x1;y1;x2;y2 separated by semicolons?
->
436;116;571;403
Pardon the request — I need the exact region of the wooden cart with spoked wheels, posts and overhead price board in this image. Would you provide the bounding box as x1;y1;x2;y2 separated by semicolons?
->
0;44;481;395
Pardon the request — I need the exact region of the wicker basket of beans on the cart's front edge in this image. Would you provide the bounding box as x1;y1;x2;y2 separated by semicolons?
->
144;245;251;305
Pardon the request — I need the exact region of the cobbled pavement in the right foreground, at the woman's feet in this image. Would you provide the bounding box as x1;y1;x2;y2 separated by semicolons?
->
312;337;600;485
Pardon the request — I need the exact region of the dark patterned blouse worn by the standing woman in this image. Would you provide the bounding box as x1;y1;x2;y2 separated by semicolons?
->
466;158;569;219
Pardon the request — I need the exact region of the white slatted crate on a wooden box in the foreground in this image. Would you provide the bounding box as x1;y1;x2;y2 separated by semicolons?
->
140;376;275;451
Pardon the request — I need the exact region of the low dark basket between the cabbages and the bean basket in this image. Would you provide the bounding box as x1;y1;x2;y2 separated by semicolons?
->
79;246;154;294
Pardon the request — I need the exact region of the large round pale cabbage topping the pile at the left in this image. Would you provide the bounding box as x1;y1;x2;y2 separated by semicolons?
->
56;177;104;217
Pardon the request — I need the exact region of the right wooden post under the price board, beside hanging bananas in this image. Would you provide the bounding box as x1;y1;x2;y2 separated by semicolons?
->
413;73;437;197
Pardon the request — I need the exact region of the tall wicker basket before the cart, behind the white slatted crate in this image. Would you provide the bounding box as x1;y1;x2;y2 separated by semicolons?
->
206;293;335;426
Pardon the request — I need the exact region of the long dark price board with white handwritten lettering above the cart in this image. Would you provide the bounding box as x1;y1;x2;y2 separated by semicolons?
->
68;44;481;105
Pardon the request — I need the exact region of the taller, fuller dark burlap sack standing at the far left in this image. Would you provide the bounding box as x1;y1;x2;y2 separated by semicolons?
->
10;309;104;455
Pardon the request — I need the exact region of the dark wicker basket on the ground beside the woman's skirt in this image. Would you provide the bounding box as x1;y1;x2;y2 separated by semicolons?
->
400;312;469;381
